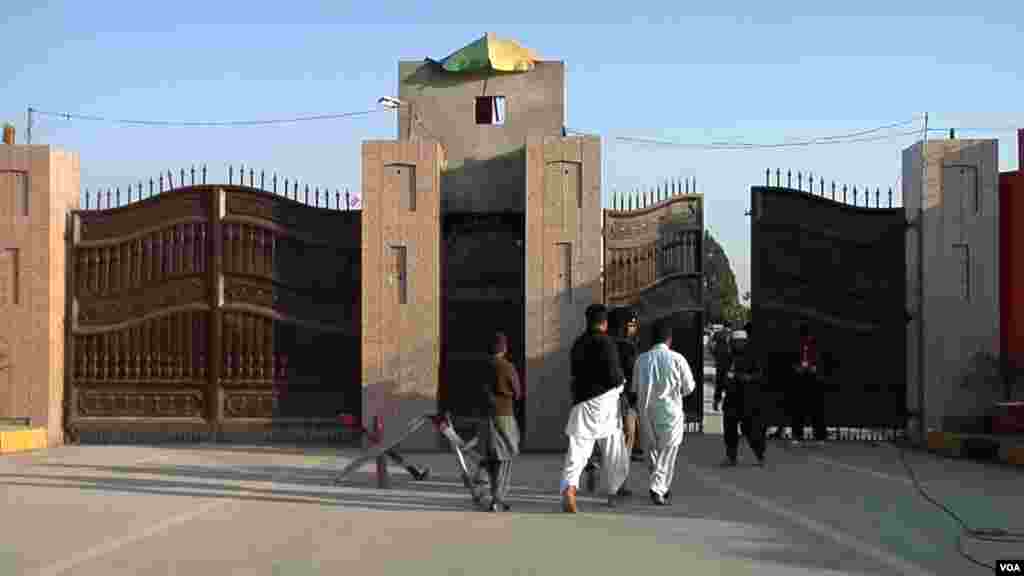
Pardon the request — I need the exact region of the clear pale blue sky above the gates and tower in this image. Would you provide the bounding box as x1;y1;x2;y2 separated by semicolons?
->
0;0;1024;293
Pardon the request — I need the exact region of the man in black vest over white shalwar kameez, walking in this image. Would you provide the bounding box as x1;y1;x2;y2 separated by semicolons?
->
559;304;629;513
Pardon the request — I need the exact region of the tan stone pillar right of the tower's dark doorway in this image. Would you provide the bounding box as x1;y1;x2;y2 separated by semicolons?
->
523;136;602;450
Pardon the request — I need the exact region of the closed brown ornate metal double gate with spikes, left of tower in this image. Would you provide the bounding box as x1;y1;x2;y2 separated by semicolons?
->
66;177;361;441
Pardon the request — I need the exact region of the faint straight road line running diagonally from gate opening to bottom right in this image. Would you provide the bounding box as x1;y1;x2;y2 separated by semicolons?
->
686;464;934;576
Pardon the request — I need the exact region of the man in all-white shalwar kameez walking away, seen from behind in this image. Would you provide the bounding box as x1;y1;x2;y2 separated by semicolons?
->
633;320;696;506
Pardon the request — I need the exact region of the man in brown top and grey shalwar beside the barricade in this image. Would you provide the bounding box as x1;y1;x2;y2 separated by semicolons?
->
473;332;522;512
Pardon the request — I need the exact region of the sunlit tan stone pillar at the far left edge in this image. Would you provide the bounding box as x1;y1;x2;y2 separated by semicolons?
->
0;146;79;446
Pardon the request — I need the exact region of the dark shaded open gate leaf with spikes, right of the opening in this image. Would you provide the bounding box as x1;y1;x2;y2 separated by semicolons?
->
751;173;907;440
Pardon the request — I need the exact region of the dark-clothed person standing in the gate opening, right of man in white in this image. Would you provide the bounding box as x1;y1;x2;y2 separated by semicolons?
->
715;323;766;466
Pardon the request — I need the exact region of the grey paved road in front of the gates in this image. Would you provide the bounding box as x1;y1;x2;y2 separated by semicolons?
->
0;428;1024;576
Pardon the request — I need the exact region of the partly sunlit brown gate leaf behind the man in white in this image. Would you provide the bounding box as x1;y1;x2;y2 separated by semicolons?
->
604;181;703;431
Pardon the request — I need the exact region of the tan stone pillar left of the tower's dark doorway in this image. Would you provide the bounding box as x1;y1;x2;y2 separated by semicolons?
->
360;139;443;449
